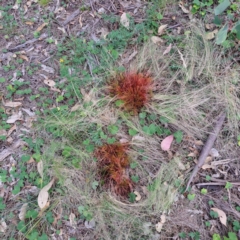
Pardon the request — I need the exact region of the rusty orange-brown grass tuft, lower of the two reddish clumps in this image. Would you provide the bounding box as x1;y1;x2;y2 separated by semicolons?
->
95;143;133;196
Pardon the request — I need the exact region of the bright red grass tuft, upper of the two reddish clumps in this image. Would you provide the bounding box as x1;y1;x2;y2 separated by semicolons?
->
109;72;153;115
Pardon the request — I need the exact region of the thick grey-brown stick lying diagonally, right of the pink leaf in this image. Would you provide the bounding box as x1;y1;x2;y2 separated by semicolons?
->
186;112;226;190
